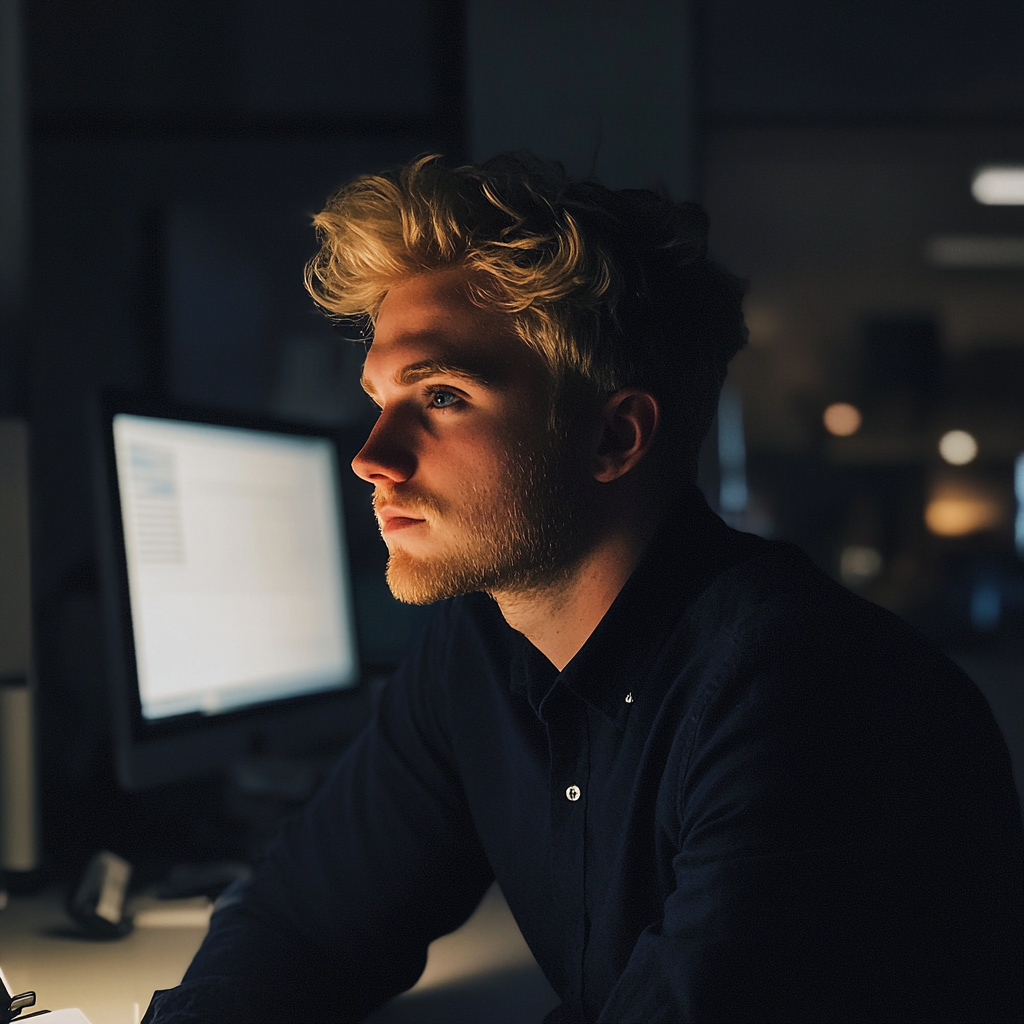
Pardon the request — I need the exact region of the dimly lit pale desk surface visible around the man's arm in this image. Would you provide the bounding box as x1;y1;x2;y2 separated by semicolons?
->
0;886;558;1024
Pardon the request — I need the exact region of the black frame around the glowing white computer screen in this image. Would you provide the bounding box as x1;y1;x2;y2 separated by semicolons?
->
94;390;366;790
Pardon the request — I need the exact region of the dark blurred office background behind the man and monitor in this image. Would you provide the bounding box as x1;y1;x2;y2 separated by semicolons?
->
0;0;1024;869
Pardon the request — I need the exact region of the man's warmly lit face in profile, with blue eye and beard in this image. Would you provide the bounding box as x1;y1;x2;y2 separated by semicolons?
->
352;270;592;604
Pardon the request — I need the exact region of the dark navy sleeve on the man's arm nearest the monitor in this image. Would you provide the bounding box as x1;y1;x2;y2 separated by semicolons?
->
145;608;493;1024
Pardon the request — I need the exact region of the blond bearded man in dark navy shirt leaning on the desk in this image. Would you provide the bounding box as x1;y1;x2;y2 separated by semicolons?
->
146;158;1022;1022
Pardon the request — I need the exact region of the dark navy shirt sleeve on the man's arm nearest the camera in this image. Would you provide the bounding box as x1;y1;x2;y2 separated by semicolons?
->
598;651;1021;1024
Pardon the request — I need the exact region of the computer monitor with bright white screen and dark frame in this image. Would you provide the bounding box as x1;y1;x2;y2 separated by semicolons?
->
95;393;365;790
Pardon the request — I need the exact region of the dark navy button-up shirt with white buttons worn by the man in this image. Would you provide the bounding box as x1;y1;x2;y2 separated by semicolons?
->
146;500;1024;1024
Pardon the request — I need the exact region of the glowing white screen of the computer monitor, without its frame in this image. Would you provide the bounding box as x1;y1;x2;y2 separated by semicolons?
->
113;413;359;721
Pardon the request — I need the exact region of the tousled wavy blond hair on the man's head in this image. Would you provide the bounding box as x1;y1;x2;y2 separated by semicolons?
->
305;154;745;468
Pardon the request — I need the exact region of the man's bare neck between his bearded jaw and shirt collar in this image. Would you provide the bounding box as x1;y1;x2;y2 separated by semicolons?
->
492;520;655;672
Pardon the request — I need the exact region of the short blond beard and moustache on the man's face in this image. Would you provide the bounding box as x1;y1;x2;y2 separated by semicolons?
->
374;431;595;604
